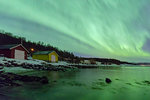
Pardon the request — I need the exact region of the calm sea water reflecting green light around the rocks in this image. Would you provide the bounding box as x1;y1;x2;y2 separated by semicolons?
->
0;67;150;100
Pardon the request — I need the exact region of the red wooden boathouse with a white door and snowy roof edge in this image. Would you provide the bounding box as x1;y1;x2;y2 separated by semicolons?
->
0;44;29;60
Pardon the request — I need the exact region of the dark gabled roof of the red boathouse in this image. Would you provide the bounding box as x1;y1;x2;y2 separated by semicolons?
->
0;44;29;53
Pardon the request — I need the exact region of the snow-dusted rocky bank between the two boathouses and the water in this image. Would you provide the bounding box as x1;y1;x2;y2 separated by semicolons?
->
0;58;76;71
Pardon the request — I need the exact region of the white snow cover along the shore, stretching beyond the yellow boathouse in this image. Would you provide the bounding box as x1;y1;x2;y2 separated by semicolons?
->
0;57;119;72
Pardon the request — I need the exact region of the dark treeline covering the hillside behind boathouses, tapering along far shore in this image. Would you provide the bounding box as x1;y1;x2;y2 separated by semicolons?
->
0;30;135;65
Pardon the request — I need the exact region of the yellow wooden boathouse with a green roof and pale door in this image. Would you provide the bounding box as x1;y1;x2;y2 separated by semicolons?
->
32;51;58;62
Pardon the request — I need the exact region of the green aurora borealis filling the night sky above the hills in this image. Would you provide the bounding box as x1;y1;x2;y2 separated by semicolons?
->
0;0;150;62
